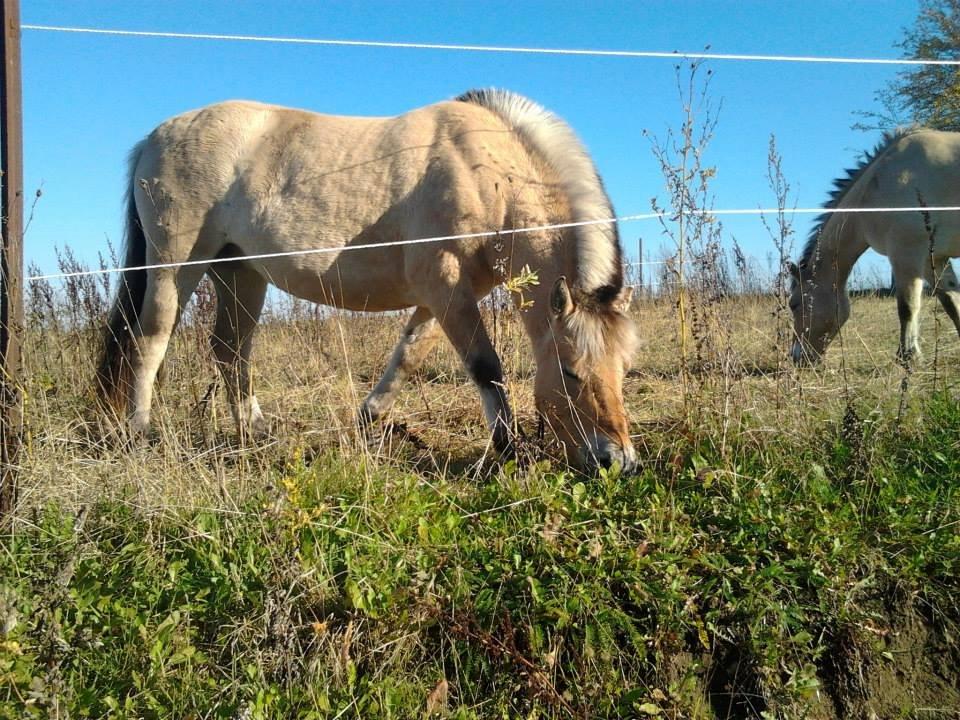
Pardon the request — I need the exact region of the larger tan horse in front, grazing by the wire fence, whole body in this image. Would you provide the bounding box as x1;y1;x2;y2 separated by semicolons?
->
98;90;636;469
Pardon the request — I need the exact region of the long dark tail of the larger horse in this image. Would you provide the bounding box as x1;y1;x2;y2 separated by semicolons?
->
96;142;147;417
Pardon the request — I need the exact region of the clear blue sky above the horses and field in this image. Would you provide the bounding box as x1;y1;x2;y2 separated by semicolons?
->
21;0;917;284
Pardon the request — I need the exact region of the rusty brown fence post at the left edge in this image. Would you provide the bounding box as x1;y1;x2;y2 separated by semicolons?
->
0;0;23;524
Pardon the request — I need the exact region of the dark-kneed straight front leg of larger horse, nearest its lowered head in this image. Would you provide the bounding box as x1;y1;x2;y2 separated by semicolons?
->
434;289;513;453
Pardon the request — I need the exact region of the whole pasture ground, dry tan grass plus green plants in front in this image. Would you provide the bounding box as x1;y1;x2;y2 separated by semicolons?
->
0;283;960;719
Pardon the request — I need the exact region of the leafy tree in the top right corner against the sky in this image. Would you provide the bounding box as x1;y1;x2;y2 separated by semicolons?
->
856;0;960;130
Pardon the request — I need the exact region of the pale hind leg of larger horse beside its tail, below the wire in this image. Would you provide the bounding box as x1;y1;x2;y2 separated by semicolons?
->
128;266;205;435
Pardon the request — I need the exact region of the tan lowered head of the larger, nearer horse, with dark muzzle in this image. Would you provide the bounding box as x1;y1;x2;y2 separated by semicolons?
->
534;277;636;471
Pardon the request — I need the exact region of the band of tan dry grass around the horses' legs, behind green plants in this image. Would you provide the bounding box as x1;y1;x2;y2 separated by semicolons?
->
20;284;960;508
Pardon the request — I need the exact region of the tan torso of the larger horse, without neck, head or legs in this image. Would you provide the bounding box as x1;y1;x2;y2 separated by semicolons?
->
133;100;537;309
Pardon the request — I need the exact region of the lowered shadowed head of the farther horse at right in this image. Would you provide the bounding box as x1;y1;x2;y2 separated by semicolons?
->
790;263;850;366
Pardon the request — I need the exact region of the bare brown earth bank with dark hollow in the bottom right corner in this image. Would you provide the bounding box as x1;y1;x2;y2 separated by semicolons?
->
664;606;960;720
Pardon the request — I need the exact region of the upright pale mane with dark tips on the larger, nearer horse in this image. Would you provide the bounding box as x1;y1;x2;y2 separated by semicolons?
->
457;89;623;304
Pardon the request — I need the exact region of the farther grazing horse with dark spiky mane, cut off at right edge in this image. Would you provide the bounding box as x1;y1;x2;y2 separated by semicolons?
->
790;129;960;364
